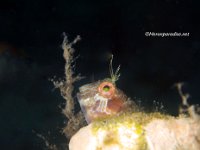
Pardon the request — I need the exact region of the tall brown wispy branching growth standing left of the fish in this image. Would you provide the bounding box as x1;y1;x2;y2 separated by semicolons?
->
52;33;84;138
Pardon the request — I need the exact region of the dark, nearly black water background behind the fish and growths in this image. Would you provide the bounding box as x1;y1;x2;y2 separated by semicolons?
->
0;0;200;150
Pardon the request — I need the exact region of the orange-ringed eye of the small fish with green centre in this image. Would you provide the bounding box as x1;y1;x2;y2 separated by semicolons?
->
98;81;115;98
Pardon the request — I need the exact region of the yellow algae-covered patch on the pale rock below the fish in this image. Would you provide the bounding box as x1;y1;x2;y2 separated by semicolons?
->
92;112;172;150
